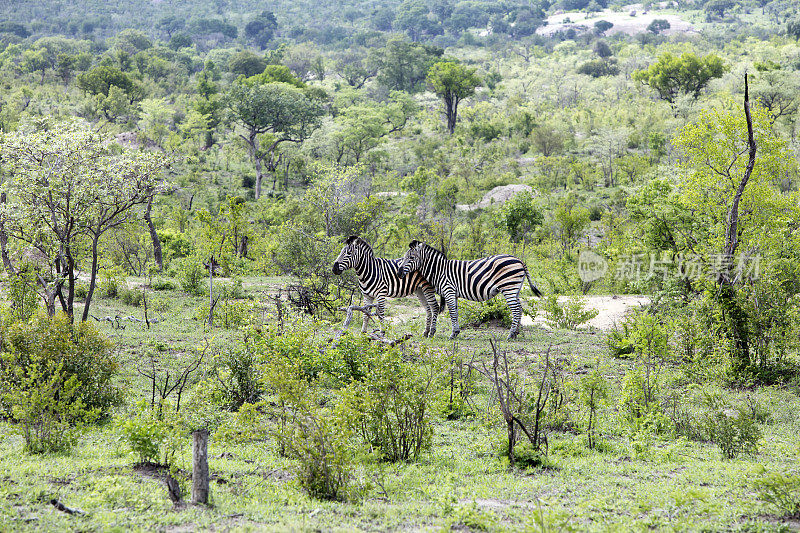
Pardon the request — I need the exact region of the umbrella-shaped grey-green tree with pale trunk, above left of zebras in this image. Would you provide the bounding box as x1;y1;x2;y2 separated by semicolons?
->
228;77;323;199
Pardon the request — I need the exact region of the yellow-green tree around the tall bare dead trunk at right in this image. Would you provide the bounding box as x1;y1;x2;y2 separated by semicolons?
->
628;96;800;370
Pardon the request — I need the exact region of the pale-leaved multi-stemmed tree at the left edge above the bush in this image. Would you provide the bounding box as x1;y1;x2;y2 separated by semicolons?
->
0;120;164;321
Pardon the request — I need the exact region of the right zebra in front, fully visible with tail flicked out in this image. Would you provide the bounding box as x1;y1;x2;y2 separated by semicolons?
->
400;241;542;339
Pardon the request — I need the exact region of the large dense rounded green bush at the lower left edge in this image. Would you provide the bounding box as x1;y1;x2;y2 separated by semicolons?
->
0;314;120;453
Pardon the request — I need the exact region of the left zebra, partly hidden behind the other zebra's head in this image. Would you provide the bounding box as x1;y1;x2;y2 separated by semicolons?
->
333;235;439;337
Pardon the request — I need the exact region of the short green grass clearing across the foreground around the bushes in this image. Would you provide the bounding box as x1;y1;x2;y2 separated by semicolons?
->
0;279;800;531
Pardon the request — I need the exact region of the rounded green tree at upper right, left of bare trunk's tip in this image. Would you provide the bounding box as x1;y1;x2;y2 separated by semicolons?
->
632;52;726;104
